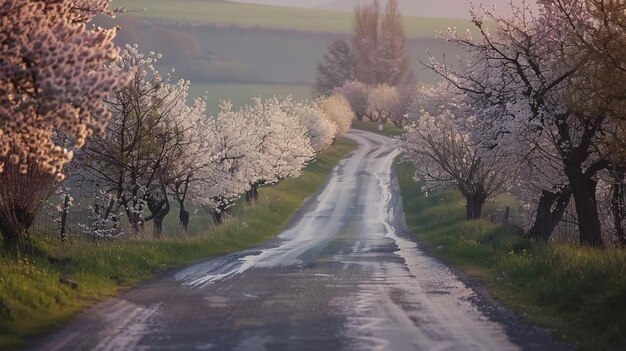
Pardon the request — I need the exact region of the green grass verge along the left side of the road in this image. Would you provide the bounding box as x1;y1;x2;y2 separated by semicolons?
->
0;138;355;349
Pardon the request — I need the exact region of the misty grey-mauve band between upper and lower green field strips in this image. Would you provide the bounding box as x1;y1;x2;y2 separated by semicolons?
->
98;16;452;84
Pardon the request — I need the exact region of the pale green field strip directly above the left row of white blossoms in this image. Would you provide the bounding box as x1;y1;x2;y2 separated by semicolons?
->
189;82;311;115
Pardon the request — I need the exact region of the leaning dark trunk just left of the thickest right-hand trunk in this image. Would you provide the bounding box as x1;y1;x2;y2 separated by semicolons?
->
529;189;571;242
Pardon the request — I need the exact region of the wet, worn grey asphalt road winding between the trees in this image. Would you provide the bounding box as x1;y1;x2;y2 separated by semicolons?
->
30;131;568;351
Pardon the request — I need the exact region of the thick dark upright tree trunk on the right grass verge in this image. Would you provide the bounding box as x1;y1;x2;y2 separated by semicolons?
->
568;174;604;248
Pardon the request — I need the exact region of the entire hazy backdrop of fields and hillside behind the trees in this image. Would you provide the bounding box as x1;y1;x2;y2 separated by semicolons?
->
103;0;469;113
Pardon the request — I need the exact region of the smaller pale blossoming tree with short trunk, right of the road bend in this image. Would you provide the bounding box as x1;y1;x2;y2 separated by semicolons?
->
398;84;512;219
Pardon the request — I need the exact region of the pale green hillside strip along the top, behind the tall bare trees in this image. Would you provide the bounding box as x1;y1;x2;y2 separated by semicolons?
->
112;0;471;38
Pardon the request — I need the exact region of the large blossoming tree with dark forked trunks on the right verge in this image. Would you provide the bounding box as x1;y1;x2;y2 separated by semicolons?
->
430;0;623;247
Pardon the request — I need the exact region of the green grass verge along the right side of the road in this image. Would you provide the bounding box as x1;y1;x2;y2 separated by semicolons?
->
397;164;626;350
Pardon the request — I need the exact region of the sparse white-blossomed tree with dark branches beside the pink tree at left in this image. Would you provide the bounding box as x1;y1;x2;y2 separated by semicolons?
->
79;45;204;235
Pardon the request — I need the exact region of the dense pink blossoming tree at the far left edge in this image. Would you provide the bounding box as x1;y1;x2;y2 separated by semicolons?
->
0;0;127;245
